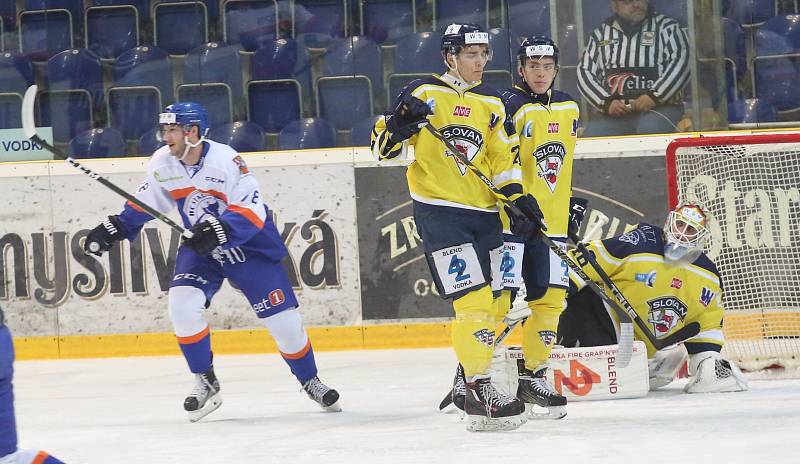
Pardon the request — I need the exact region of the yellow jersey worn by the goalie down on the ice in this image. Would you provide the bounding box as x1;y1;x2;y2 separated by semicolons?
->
570;223;725;357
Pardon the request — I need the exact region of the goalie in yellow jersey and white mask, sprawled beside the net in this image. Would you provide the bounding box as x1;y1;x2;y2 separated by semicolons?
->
558;203;747;393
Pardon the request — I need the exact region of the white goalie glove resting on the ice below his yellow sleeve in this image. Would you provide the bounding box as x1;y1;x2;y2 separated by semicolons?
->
683;351;749;393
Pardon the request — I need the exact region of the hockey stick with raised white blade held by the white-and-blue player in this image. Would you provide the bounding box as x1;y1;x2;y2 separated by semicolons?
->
22;85;192;248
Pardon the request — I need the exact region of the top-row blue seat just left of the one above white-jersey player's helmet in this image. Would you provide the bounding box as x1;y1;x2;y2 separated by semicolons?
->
85;5;140;60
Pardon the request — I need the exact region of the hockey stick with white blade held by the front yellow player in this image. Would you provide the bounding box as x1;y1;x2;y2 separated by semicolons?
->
425;123;637;367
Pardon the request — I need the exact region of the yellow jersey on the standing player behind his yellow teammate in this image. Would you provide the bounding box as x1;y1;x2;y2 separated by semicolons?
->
501;86;580;237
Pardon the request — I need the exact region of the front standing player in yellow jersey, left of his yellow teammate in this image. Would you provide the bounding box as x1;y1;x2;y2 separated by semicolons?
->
372;24;541;430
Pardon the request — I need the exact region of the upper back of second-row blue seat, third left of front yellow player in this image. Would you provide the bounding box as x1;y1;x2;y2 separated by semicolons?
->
251;39;311;95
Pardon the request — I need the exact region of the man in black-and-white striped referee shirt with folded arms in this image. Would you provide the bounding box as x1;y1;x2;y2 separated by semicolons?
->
578;0;689;136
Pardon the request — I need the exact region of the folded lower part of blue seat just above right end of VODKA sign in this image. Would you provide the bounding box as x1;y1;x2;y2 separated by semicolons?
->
36;89;94;143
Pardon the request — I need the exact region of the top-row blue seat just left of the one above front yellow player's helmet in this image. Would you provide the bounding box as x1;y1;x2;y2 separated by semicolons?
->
358;0;417;43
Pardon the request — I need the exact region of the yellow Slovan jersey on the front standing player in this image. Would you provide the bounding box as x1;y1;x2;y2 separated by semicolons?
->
372;75;522;211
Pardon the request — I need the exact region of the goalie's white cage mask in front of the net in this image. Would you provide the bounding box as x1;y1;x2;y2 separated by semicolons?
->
664;203;709;264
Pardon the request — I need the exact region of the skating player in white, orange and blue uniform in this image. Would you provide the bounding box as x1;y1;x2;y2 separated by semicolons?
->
84;102;339;422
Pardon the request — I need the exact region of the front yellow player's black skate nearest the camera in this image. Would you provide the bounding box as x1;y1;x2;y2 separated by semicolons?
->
464;378;526;432
